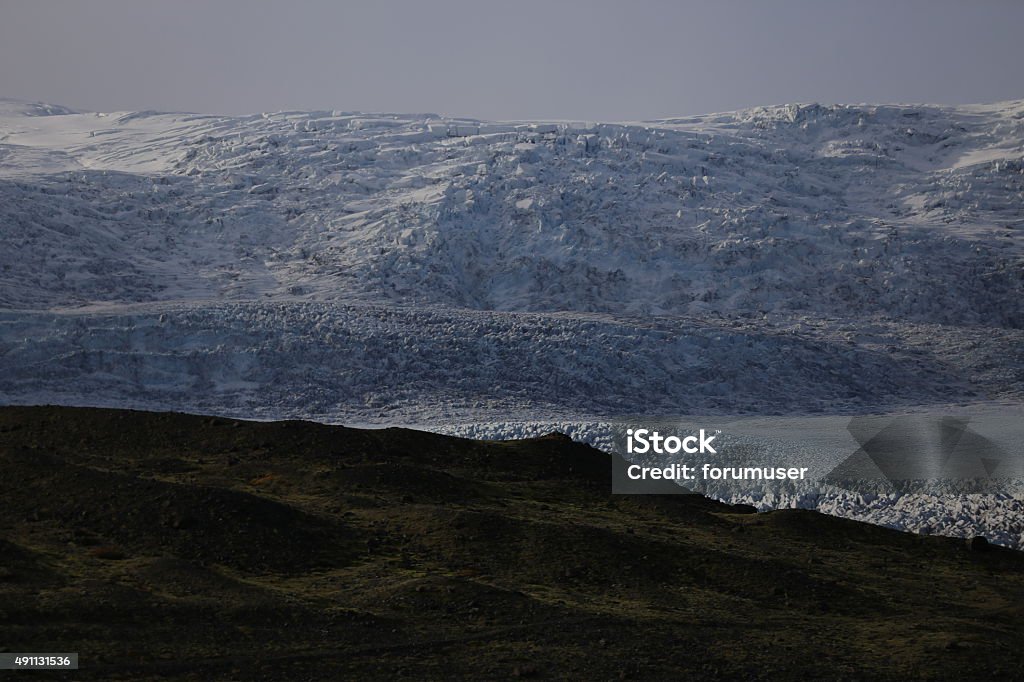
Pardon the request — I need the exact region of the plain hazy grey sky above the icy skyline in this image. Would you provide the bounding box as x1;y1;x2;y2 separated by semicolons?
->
0;0;1024;121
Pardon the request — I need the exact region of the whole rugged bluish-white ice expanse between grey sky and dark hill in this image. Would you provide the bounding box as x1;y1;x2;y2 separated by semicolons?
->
0;95;1024;545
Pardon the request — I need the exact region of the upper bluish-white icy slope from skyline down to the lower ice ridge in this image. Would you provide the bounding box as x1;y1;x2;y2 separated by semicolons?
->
0;102;1024;328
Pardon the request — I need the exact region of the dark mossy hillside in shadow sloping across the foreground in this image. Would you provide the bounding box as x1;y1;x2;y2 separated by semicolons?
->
0;407;1024;680
